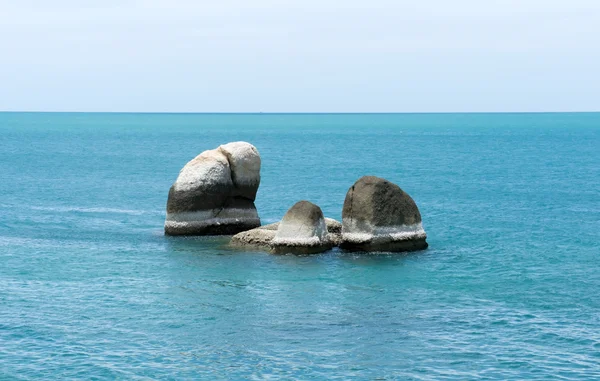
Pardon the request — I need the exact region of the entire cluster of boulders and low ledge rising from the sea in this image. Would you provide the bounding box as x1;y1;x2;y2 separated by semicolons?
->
165;142;428;254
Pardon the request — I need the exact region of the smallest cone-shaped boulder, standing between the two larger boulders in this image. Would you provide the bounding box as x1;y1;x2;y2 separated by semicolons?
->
271;201;333;254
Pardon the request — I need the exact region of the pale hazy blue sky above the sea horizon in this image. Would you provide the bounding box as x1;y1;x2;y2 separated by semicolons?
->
0;0;600;112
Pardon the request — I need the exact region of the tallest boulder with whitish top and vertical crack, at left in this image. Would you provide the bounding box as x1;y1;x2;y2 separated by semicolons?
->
165;142;260;235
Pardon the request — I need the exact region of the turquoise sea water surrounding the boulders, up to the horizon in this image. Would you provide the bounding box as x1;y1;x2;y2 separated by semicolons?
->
0;113;600;380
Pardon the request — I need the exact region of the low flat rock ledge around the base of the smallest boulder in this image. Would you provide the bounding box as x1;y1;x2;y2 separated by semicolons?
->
231;211;342;253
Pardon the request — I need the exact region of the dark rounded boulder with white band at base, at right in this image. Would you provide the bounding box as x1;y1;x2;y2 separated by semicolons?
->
340;176;428;252
